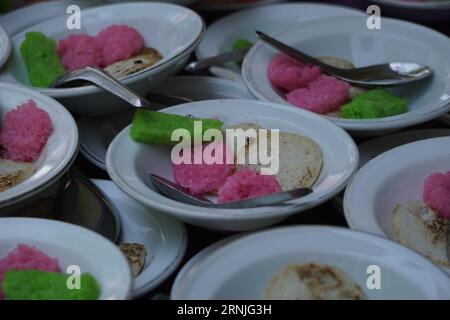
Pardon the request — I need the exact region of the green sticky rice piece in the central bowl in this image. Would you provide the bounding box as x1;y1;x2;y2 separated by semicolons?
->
130;110;223;145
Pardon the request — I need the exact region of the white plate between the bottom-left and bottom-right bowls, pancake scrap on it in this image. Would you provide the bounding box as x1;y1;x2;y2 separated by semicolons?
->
93;180;187;298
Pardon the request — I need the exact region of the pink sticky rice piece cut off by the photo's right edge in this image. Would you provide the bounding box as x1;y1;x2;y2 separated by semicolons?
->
423;171;450;219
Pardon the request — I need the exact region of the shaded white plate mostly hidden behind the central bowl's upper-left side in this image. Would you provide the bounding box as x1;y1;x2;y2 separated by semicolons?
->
78;77;253;170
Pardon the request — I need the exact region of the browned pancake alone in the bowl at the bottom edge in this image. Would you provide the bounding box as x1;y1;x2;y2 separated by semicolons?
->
264;263;367;300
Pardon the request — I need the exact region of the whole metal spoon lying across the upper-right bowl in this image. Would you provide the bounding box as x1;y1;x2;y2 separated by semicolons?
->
256;31;433;86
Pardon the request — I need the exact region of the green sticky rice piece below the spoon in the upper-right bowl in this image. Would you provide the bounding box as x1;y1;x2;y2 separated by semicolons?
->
341;88;408;119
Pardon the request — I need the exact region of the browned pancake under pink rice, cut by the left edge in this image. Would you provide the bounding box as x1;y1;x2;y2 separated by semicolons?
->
0;158;35;192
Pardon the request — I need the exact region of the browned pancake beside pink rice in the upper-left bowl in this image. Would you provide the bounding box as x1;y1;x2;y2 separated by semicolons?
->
105;48;162;79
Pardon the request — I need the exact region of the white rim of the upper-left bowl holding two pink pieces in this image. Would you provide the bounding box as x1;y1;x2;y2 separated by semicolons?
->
4;2;206;98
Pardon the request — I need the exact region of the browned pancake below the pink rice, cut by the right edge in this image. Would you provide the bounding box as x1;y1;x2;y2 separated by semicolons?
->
391;201;450;267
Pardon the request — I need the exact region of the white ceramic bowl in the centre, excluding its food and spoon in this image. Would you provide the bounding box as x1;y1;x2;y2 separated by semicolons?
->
106;100;358;231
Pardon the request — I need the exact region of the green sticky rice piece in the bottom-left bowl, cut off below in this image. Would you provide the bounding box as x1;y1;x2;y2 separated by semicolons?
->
2;270;100;300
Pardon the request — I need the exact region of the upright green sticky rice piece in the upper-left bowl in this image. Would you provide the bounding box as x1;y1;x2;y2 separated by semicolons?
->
20;32;65;88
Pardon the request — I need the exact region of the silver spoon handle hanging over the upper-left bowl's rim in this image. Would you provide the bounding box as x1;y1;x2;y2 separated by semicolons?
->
52;67;150;108
